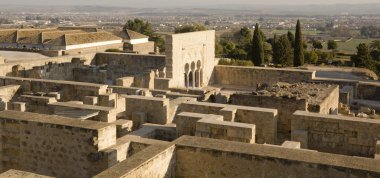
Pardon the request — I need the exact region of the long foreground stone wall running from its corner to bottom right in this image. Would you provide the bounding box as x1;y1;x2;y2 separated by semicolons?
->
175;136;380;178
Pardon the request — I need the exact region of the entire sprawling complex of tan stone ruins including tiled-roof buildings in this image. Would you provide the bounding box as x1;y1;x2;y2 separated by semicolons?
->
0;27;380;178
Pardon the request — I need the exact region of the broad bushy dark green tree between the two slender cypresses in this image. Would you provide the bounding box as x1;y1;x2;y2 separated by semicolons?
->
273;35;293;67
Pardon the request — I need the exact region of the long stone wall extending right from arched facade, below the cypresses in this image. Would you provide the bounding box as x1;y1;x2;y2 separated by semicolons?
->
215;65;315;88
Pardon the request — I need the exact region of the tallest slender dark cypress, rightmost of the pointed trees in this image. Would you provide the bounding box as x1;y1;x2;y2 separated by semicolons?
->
294;20;305;67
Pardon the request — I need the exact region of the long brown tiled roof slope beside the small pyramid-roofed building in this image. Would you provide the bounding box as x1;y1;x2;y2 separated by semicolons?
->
65;32;121;45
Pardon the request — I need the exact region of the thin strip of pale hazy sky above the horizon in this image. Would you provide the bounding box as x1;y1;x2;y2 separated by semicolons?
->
0;0;380;7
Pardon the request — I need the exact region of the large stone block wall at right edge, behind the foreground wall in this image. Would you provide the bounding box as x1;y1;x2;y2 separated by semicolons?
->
292;111;380;157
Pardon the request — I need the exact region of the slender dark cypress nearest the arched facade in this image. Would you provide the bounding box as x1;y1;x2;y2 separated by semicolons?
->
252;23;264;66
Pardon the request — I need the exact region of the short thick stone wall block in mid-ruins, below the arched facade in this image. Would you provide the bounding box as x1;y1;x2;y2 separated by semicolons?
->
125;96;172;125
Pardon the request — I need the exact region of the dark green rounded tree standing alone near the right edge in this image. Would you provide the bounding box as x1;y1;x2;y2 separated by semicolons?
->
351;43;372;68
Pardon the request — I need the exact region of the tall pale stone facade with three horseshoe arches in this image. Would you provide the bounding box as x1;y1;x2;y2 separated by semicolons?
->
165;31;217;88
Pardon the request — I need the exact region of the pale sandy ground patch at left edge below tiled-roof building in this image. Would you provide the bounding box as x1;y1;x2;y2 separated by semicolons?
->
0;51;49;62
